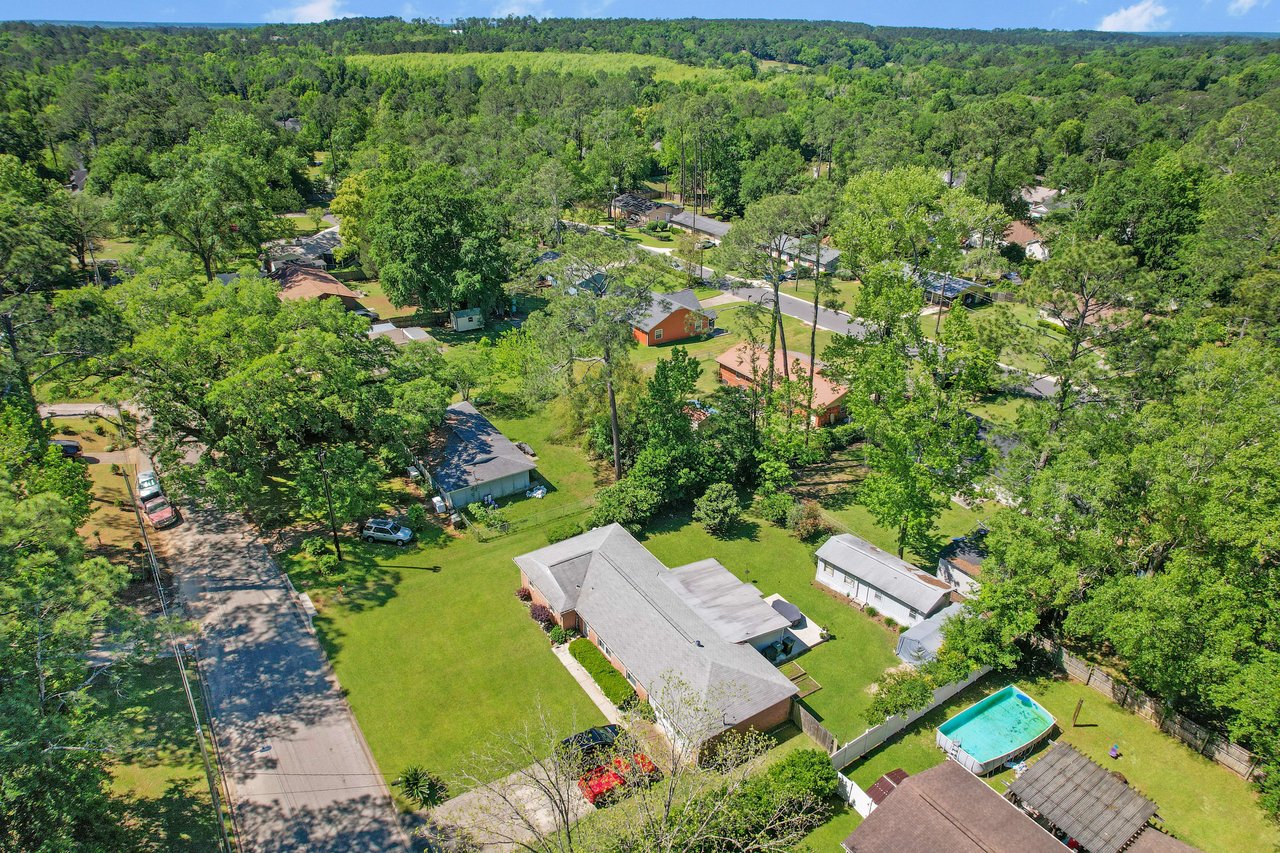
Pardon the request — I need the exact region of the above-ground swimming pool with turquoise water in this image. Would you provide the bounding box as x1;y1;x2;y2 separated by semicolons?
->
938;684;1056;776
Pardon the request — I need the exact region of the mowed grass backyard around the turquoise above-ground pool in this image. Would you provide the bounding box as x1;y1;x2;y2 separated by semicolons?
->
845;674;1280;853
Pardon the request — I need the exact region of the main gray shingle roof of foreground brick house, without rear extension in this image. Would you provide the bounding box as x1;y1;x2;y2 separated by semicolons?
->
516;524;796;736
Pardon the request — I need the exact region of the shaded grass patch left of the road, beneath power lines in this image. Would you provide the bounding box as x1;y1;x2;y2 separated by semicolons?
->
97;660;218;853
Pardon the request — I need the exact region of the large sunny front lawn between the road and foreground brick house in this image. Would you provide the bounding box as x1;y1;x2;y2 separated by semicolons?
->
285;404;603;793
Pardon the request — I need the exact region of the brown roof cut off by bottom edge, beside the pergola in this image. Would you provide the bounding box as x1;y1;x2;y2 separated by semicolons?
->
841;761;1066;853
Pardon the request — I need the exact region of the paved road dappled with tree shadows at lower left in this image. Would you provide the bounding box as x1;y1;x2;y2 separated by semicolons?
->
154;510;408;853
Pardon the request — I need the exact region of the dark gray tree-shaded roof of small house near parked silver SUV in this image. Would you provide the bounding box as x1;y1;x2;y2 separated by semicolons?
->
430;401;538;492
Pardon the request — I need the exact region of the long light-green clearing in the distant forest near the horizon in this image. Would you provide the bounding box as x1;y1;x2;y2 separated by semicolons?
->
347;50;724;83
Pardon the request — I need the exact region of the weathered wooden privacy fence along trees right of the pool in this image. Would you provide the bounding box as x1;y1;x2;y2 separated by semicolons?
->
1039;639;1258;780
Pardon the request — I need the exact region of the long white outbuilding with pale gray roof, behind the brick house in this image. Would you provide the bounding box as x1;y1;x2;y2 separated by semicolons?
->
817;533;951;628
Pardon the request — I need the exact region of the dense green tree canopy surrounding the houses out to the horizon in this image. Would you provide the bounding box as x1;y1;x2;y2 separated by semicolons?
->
0;18;1280;849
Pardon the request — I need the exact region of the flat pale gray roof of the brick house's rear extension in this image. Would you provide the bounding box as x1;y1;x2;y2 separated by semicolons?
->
663;558;791;643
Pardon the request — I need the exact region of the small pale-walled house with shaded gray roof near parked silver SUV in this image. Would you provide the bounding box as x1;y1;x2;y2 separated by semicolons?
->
428;401;538;510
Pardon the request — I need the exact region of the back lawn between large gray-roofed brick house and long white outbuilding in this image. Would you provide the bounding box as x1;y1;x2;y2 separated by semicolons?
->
644;514;899;740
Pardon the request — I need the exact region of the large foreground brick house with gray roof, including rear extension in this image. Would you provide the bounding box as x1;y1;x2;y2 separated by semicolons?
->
516;524;796;745
